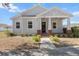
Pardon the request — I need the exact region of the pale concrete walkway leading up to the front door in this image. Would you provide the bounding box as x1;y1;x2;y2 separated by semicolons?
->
40;37;55;49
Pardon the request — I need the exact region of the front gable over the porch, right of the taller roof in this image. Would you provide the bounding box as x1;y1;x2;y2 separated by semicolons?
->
38;8;72;17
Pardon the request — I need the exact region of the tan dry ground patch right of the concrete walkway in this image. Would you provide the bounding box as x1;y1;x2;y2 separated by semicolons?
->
54;38;79;47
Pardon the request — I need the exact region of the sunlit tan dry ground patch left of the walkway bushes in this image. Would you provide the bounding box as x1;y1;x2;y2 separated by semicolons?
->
0;36;33;51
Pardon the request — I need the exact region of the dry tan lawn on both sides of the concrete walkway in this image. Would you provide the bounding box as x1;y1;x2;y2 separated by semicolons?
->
0;32;79;51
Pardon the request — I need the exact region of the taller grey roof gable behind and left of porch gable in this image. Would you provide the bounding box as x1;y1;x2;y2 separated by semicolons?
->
21;5;47;17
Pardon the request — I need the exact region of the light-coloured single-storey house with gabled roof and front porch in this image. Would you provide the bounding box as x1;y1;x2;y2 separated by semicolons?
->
11;5;73;35
